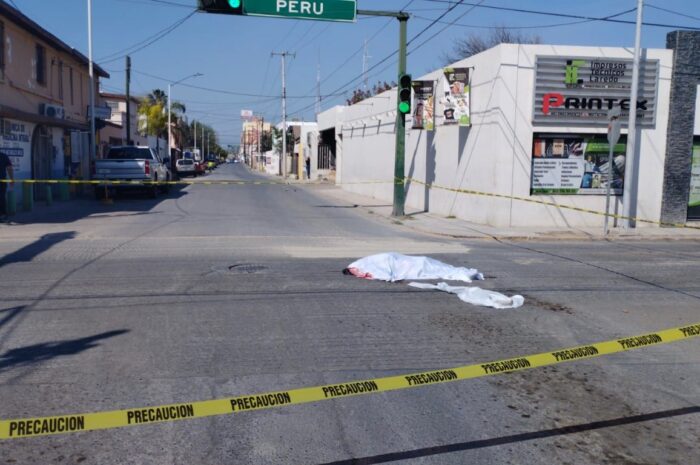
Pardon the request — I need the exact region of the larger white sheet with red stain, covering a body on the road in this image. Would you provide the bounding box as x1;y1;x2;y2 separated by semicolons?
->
347;253;484;283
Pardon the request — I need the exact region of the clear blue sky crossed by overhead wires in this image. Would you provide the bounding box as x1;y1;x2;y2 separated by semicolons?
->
6;0;700;146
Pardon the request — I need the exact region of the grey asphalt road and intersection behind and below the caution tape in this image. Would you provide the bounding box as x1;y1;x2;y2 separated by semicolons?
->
0;165;700;465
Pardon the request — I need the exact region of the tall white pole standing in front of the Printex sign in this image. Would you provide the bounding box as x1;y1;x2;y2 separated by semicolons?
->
622;0;644;229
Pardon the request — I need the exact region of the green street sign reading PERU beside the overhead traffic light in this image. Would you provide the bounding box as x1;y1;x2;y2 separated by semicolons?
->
243;0;357;22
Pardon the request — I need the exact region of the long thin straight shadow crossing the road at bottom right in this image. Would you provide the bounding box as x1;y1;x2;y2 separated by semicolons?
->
323;406;700;465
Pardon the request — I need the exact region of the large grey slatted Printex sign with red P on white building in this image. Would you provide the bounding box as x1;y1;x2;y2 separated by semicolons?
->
532;56;659;128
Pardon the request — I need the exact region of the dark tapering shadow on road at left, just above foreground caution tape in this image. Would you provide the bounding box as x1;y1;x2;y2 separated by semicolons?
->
0;329;129;372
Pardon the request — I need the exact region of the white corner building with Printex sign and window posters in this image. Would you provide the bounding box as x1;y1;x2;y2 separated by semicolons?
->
316;32;700;227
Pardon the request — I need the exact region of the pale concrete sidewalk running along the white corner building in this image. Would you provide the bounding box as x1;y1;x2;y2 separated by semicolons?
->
305;183;700;241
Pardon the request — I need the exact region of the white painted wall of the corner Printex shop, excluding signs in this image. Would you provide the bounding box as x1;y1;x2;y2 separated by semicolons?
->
326;45;672;227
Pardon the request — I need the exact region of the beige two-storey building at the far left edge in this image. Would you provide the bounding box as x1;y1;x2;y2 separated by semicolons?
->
0;2;109;193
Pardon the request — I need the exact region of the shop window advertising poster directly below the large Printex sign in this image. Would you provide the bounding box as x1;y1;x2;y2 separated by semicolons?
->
530;134;627;195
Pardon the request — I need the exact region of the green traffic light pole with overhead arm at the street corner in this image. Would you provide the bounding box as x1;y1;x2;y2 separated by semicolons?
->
357;10;409;217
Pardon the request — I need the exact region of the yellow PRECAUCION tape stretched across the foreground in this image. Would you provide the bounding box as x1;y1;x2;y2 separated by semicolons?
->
0;323;700;439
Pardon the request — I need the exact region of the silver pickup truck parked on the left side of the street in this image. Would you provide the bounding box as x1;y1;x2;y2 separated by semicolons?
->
93;146;172;199
